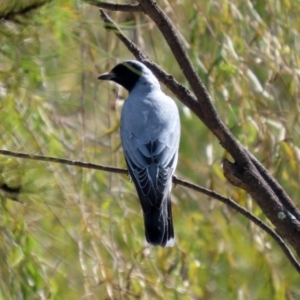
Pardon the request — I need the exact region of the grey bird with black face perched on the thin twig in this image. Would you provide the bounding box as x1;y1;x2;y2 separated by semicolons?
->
98;60;180;247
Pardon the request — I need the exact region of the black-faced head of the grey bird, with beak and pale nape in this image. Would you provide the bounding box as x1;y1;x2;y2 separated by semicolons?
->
98;60;159;92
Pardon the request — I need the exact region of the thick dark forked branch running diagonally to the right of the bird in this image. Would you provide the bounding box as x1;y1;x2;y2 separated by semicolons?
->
100;0;300;256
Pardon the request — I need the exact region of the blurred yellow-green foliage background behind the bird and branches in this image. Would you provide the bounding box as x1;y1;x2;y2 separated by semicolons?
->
0;0;300;300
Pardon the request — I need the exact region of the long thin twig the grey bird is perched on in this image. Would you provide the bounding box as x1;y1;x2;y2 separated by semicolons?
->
0;149;300;273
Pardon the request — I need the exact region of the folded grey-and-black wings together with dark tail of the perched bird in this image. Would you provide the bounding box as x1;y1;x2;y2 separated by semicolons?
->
122;132;179;246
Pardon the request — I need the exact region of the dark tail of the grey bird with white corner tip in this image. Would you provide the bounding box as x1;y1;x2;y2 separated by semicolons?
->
144;194;174;247
